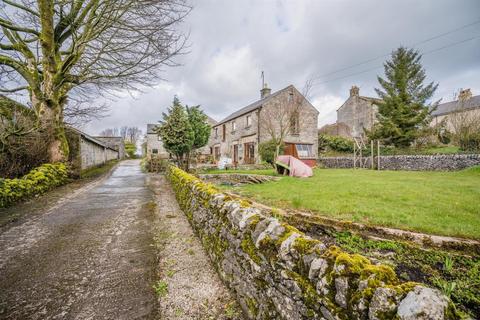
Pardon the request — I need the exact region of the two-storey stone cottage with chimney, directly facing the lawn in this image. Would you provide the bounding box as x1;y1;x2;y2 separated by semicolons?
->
209;85;318;166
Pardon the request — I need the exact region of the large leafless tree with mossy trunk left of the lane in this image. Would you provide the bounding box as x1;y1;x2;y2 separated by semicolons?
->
0;0;190;161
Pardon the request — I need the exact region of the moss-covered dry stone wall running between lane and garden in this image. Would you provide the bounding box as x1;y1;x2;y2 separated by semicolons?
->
167;166;457;320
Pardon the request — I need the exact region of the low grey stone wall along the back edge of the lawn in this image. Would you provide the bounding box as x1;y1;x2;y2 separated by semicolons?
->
318;154;480;171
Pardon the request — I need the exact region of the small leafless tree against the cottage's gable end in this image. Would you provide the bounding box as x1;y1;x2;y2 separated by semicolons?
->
260;80;312;159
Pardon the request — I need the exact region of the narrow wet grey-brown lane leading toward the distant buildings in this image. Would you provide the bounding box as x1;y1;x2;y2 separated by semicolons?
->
0;160;238;319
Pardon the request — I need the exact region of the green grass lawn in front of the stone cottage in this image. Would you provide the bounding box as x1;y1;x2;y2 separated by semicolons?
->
223;167;480;239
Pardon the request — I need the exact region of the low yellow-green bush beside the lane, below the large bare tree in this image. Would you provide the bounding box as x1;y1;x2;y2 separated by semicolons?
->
0;163;68;208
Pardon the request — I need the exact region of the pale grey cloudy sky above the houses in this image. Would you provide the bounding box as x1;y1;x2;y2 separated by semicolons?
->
84;0;480;134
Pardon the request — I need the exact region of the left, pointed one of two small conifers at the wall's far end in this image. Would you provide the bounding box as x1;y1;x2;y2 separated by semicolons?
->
157;96;195;170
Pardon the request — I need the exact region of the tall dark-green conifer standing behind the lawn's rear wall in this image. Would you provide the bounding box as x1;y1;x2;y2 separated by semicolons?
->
369;47;438;147
